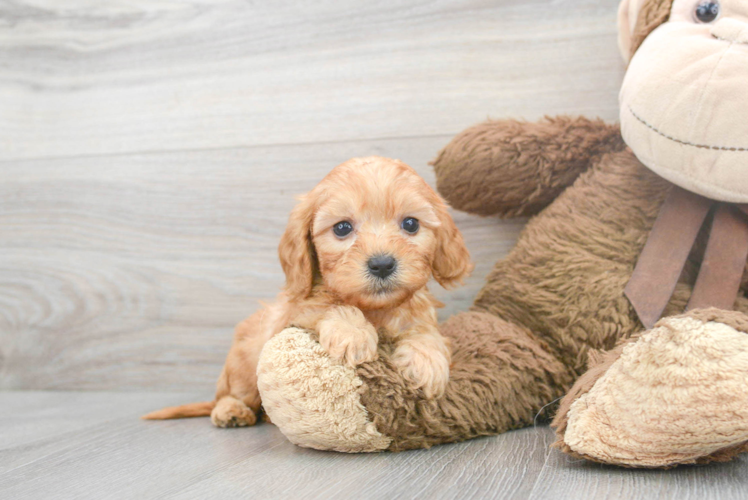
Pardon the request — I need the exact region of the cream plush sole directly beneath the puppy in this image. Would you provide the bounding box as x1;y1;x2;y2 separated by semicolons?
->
257;328;392;453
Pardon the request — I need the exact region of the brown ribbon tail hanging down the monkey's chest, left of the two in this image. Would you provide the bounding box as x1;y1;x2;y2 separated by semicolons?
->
624;186;715;328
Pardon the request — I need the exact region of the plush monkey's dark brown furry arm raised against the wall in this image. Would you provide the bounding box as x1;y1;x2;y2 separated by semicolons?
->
433;117;625;217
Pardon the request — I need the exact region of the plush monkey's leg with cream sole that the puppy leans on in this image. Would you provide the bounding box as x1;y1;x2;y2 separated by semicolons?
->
257;312;573;452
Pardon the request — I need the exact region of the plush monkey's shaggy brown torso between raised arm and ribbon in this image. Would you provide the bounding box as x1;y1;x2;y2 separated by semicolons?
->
475;146;669;375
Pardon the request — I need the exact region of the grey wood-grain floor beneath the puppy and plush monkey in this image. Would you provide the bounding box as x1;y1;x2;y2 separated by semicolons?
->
0;391;748;500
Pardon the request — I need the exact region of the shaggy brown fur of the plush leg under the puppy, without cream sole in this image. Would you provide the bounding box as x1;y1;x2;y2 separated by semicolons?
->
358;313;572;451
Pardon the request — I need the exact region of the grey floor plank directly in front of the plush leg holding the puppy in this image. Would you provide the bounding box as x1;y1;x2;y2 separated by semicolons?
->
170;427;549;499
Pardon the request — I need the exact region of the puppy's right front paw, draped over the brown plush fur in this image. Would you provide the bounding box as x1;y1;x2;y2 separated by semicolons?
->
392;339;450;399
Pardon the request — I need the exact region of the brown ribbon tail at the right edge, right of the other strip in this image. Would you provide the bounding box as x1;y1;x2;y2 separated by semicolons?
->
686;205;748;310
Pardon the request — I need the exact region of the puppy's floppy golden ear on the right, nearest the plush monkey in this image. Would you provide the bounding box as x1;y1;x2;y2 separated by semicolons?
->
431;198;473;288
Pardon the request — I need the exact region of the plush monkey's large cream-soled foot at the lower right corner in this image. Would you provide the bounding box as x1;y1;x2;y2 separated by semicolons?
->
553;309;748;468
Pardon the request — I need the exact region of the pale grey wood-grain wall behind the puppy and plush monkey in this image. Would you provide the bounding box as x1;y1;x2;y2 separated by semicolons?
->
0;0;623;390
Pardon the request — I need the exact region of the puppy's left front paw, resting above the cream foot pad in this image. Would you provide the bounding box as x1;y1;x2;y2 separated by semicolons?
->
319;306;379;367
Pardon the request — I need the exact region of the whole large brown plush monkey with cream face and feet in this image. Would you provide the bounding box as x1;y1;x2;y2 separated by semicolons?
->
253;0;748;467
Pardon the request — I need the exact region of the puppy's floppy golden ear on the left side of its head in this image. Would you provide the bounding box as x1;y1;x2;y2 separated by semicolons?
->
278;194;317;300
